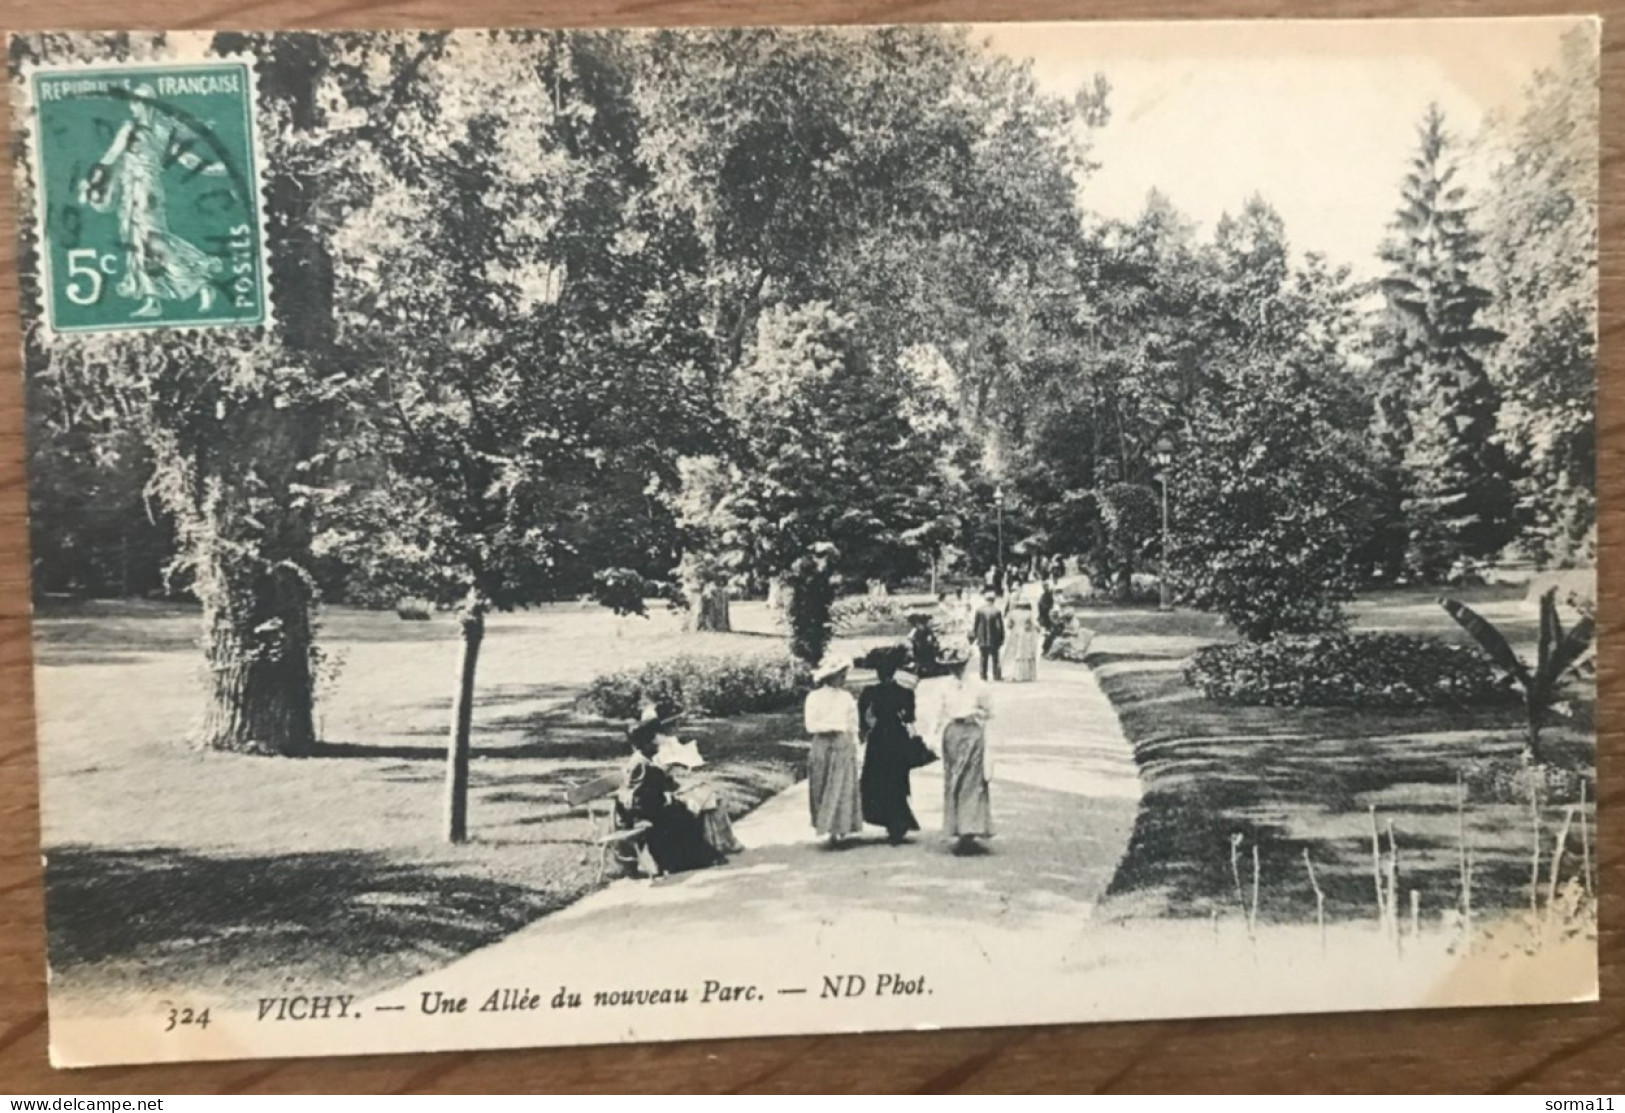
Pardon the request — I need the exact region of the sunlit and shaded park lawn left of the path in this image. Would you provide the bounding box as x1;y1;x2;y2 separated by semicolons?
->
36;604;832;1011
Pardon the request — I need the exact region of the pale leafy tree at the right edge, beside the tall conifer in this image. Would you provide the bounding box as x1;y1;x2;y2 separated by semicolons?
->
1479;28;1597;564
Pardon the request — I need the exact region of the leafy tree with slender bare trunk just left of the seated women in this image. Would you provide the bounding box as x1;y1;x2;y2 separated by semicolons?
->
325;32;707;842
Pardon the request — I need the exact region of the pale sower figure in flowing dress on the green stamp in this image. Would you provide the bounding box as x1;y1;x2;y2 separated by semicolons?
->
80;84;226;317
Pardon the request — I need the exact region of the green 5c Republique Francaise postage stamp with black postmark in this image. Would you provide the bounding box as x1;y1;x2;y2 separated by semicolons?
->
26;58;270;331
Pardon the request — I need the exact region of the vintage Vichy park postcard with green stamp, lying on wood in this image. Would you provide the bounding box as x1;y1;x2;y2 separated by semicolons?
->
10;18;1599;1066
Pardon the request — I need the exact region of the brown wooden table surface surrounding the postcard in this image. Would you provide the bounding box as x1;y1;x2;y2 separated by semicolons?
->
0;0;1625;1095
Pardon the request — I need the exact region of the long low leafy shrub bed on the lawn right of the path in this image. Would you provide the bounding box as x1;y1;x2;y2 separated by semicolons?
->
1185;632;1513;707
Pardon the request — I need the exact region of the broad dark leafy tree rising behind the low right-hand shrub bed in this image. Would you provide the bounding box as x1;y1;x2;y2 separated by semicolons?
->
1168;198;1375;640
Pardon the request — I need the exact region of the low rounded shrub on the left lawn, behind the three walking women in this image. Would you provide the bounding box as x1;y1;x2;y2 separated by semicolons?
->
577;653;813;718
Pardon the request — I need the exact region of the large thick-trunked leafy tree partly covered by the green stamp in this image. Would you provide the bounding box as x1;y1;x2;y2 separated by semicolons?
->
13;36;355;754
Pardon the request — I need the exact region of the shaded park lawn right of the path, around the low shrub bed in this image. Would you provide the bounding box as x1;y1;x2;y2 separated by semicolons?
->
1077;588;1596;923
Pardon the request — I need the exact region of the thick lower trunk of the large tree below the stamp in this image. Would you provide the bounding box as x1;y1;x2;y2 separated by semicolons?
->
202;557;315;756
